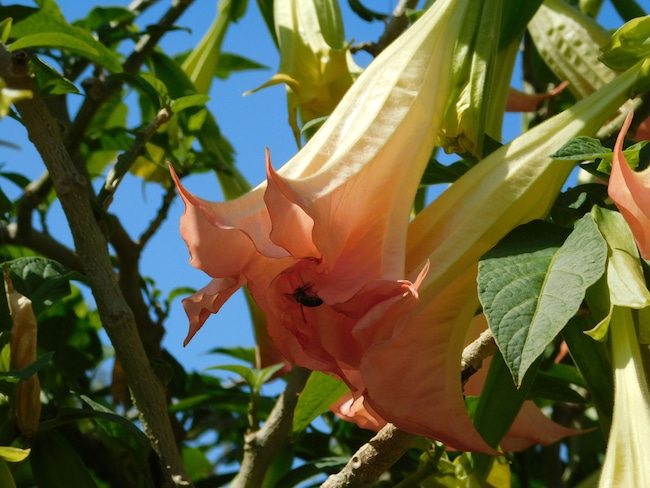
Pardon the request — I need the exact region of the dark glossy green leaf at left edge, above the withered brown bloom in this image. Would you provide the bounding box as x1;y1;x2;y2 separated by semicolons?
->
7;257;85;316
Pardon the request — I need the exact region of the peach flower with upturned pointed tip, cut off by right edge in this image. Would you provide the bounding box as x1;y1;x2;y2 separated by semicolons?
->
607;112;650;259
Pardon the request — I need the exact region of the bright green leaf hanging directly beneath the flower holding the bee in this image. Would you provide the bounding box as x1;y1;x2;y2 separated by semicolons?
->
292;371;350;434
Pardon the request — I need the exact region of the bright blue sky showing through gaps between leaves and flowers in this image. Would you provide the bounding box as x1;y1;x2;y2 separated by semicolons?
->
0;0;619;378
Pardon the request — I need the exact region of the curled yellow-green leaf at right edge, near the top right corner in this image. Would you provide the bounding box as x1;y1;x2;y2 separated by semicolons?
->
599;15;650;71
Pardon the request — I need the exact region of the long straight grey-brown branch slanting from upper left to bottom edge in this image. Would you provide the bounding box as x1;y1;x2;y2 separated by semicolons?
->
0;46;191;487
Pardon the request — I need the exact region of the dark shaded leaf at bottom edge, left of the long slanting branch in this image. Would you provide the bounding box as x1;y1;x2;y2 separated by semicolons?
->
30;431;97;488
